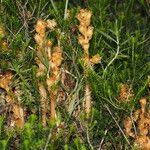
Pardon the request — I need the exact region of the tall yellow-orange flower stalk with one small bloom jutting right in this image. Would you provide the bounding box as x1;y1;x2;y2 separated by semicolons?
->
77;9;101;115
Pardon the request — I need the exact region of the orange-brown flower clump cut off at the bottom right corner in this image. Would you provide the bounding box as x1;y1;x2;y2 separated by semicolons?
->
124;98;150;150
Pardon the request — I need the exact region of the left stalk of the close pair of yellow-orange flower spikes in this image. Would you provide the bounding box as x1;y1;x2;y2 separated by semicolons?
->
34;20;47;126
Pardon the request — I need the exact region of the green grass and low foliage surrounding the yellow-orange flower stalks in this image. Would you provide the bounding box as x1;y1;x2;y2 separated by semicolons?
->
0;0;150;150
